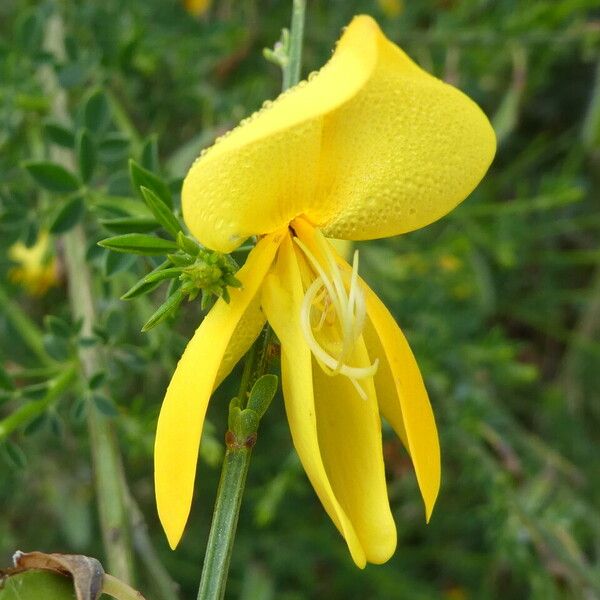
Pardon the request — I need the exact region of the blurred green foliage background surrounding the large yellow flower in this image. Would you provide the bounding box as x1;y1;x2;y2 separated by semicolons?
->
0;0;600;600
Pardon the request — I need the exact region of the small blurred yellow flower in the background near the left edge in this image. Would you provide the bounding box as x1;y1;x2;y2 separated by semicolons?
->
8;231;58;296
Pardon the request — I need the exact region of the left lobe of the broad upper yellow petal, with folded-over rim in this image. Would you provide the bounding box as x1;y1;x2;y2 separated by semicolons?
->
182;17;378;252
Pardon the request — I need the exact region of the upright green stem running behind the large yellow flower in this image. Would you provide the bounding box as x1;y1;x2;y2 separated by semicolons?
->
198;0;306;600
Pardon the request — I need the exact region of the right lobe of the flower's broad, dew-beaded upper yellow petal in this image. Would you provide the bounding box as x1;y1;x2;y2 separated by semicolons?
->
318;17;496;240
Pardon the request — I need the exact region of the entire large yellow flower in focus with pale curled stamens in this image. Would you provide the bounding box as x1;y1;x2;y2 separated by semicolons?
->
155;16;495;567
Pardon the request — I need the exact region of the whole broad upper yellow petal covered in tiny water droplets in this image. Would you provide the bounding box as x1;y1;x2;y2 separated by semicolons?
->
182;16;495;251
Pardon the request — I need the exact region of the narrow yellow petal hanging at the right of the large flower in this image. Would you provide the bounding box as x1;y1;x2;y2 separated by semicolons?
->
363;282;441;521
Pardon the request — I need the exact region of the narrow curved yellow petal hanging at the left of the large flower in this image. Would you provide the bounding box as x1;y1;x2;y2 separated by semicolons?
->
154;232;284;548
